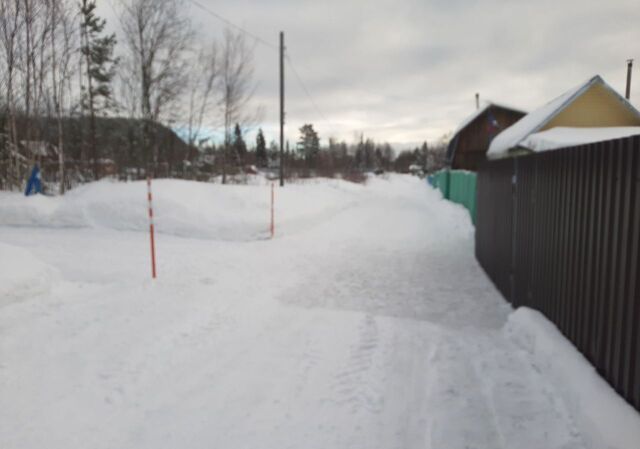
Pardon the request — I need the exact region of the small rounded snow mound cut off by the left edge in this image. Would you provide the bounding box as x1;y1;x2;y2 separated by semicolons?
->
0;243;56;307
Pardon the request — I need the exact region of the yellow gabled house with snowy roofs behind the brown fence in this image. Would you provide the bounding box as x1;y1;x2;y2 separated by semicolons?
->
487;75;640;159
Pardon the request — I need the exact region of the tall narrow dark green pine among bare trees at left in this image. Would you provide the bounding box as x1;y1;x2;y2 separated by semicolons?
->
80;0;118;179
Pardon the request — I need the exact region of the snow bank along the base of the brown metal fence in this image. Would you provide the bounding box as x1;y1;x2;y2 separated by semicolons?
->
504;307;640;449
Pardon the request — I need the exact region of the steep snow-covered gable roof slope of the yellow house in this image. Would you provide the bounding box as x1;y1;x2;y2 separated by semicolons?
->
487;75;640;159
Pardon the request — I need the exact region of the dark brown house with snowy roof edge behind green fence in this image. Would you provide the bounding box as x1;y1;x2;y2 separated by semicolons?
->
447;103;526;171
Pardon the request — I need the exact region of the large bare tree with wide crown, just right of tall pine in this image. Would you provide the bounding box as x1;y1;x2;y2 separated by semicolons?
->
120;0;193;173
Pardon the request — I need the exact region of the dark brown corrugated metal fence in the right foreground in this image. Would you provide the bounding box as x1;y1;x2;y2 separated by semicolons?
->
476;136;640;410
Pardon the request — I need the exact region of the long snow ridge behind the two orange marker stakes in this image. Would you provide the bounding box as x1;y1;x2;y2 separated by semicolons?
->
0;179;363;240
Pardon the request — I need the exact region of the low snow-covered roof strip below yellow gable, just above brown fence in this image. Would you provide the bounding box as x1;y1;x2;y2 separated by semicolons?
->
520;126;640;152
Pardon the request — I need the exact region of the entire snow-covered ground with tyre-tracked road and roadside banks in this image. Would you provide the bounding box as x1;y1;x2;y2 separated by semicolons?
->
0;176;640;449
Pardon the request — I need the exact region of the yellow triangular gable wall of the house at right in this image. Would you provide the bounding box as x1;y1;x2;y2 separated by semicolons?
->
541;84;640;131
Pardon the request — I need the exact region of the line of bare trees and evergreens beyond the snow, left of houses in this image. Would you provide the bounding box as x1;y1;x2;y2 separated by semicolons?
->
0;0;448;193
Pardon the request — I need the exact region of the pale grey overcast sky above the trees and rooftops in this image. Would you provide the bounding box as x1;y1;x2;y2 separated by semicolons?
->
99;0;640;149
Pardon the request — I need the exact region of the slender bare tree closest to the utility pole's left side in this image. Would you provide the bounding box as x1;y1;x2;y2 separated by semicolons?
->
219;29;255;184
